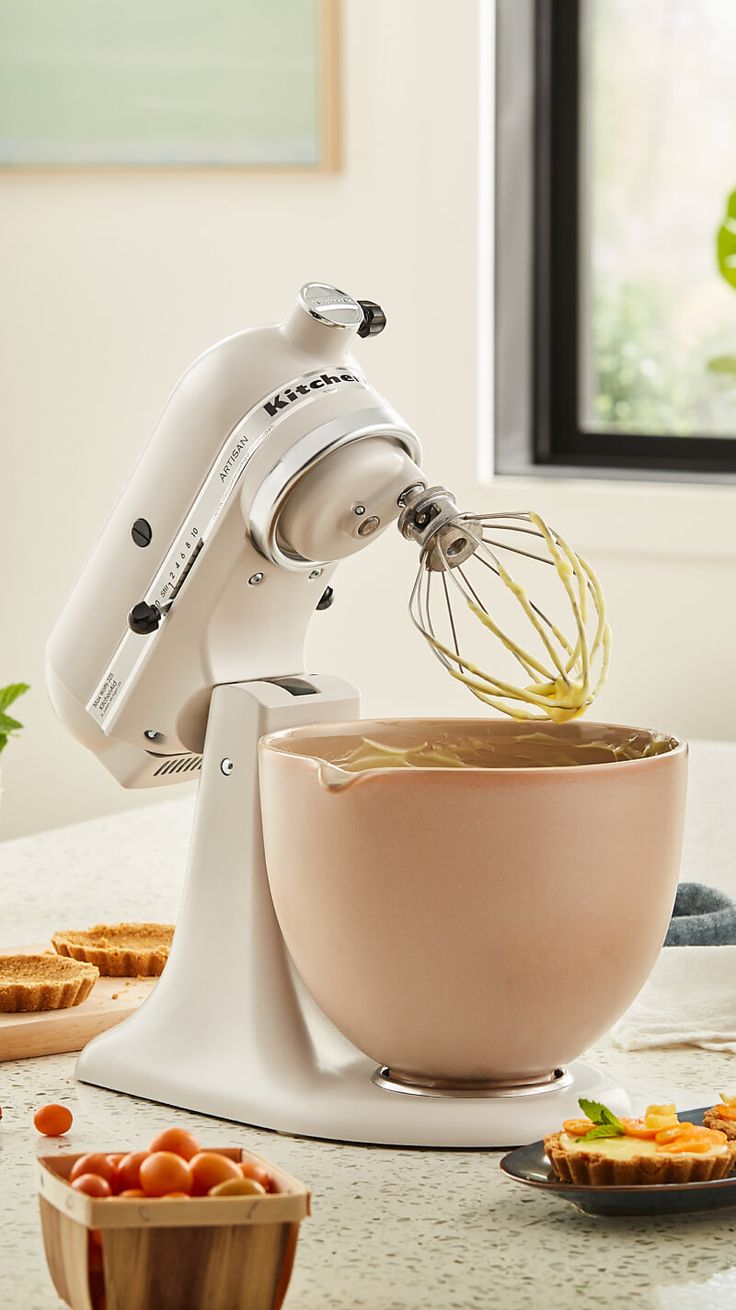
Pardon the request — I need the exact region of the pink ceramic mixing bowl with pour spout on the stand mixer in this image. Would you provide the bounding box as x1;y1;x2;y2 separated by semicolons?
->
261;719;688;1083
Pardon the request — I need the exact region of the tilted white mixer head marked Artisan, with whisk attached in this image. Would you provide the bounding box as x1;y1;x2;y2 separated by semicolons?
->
47;283;609;786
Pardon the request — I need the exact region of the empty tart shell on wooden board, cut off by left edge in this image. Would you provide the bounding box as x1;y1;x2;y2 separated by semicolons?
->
0;954;100;1014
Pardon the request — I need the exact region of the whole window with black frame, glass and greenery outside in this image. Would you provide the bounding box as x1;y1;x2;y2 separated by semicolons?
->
495;0;736;474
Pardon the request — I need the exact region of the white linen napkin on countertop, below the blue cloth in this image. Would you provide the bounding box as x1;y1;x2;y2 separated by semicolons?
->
612;946;736;1052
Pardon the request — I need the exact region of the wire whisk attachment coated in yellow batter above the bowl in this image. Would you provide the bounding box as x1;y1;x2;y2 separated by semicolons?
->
398;486;610;723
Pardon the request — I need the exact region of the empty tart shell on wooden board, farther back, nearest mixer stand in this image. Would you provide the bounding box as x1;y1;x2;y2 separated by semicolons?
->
51;924;174;979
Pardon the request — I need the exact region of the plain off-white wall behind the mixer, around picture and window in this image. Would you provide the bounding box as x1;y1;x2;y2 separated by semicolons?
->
0;0;736;837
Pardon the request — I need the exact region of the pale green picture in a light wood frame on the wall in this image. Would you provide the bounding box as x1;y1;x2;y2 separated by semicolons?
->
0;0;339;172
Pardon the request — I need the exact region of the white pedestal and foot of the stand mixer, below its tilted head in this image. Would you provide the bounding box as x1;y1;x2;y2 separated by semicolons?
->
77;676;630;1149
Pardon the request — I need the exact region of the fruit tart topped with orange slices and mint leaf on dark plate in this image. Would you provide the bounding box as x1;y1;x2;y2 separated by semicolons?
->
545;1099;736;1187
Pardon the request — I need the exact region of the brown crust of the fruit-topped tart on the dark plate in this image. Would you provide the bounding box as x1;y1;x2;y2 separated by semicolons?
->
545;1124;736;1187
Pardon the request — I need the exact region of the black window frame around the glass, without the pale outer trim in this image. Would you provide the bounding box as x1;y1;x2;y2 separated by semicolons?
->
532;0;736;474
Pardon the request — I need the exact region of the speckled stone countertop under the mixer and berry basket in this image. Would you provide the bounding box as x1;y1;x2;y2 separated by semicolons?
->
0;744;736;1310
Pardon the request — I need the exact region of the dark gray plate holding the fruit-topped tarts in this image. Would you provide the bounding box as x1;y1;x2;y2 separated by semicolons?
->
500;1106;736;1214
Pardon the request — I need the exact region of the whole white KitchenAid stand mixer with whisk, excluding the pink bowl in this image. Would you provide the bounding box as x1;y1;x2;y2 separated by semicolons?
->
47;283;627;1146
